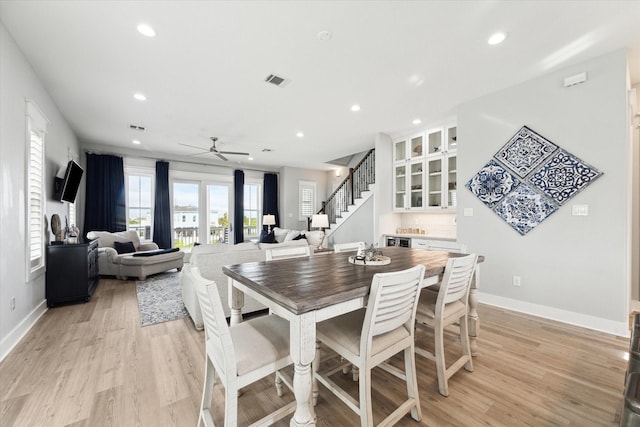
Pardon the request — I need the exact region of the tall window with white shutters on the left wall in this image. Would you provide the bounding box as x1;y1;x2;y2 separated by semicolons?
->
25;101;48;281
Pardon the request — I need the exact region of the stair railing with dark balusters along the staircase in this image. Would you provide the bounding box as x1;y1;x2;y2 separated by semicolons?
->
307;148;376;231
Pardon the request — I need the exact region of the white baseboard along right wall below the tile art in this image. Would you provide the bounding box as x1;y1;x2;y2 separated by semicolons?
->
478;292;629;337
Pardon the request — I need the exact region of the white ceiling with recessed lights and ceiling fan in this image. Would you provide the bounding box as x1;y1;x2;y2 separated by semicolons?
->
0;0;640;169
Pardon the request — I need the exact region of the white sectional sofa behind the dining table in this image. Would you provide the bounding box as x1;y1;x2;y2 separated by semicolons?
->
182;229;323;330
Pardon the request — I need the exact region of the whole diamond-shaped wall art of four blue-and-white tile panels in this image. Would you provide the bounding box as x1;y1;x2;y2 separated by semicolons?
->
465;126;602;236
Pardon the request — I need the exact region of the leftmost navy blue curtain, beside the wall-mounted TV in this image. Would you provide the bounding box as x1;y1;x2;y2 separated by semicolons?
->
84;153;127;234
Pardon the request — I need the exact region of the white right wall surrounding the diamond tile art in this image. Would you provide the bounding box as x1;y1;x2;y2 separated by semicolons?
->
458;47;630;334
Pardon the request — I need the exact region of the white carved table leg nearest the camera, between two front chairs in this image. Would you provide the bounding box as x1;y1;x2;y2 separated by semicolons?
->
290;312;316;426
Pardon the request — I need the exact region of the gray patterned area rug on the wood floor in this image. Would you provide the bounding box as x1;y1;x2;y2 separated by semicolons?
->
136;272;188;326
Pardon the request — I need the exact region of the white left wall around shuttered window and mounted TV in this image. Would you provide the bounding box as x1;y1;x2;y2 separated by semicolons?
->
0;24;83;360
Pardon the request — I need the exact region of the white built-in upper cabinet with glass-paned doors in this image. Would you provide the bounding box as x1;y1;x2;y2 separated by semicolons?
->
393;124;458;211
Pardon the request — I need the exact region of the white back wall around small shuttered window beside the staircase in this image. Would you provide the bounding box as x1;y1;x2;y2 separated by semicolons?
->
278;167;328;230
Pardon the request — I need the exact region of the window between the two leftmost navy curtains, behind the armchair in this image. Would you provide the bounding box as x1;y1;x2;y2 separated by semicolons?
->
127;173;154;240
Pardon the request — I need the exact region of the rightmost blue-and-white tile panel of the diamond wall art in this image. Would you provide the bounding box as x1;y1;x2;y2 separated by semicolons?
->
529;150;602;205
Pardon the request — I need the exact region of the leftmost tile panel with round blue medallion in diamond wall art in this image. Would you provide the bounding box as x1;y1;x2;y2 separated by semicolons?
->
466;160;520;207
